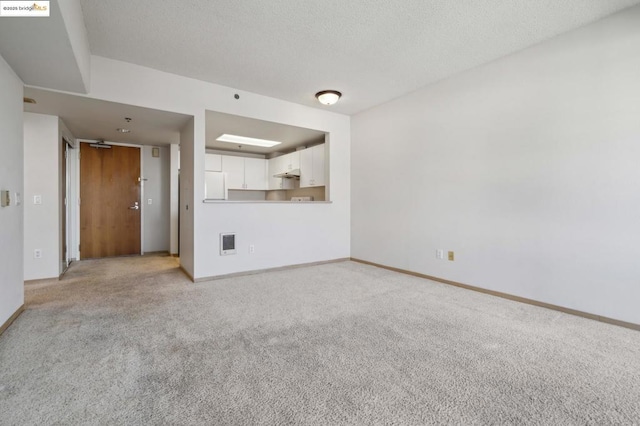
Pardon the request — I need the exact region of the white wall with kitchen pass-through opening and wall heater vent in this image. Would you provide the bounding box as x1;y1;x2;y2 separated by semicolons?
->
89;56;351;278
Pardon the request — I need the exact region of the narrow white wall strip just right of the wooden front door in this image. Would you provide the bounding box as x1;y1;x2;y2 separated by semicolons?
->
141;146;170;253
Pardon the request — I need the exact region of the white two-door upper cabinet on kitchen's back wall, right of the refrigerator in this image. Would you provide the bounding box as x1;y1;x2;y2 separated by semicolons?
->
222;155;267;191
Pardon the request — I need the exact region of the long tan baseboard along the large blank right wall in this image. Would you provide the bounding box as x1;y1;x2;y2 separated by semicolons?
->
351;257;640;331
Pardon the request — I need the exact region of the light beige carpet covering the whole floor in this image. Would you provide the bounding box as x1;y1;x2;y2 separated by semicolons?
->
0;256;640;425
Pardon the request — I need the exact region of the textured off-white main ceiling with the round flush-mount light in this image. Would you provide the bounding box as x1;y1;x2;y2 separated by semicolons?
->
81;0;640;114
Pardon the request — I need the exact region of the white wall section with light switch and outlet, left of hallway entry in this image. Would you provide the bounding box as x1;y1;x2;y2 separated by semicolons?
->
24;112;60;280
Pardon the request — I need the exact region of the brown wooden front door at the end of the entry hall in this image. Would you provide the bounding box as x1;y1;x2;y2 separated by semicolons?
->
80;143;141;259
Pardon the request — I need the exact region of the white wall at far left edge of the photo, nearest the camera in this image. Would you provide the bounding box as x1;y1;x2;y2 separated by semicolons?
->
0;56;24;325
